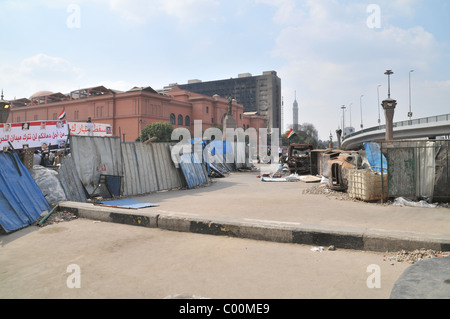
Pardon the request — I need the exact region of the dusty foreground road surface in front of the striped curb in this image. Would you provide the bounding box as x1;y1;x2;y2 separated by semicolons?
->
0;219;409;299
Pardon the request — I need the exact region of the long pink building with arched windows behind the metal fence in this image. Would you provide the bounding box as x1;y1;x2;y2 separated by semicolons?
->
8;86;267;141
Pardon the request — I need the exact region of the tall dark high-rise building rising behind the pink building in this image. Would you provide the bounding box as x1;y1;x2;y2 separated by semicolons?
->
163;71;281;129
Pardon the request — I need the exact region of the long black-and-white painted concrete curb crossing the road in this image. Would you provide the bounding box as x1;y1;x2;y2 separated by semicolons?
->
59;202;450;252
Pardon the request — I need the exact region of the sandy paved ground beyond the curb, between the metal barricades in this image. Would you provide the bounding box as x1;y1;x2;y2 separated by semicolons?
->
132;171;450;235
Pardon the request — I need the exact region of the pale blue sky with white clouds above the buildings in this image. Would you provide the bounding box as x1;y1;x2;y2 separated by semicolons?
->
0;0;450;140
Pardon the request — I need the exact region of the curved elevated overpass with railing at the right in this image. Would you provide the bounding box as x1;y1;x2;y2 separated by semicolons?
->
342;114;450;150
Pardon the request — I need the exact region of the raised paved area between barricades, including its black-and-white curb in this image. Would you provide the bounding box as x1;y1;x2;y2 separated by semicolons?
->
60;171;450;255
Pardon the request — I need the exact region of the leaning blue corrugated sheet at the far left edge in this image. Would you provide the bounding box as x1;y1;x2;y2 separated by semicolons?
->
0;153;51;233
